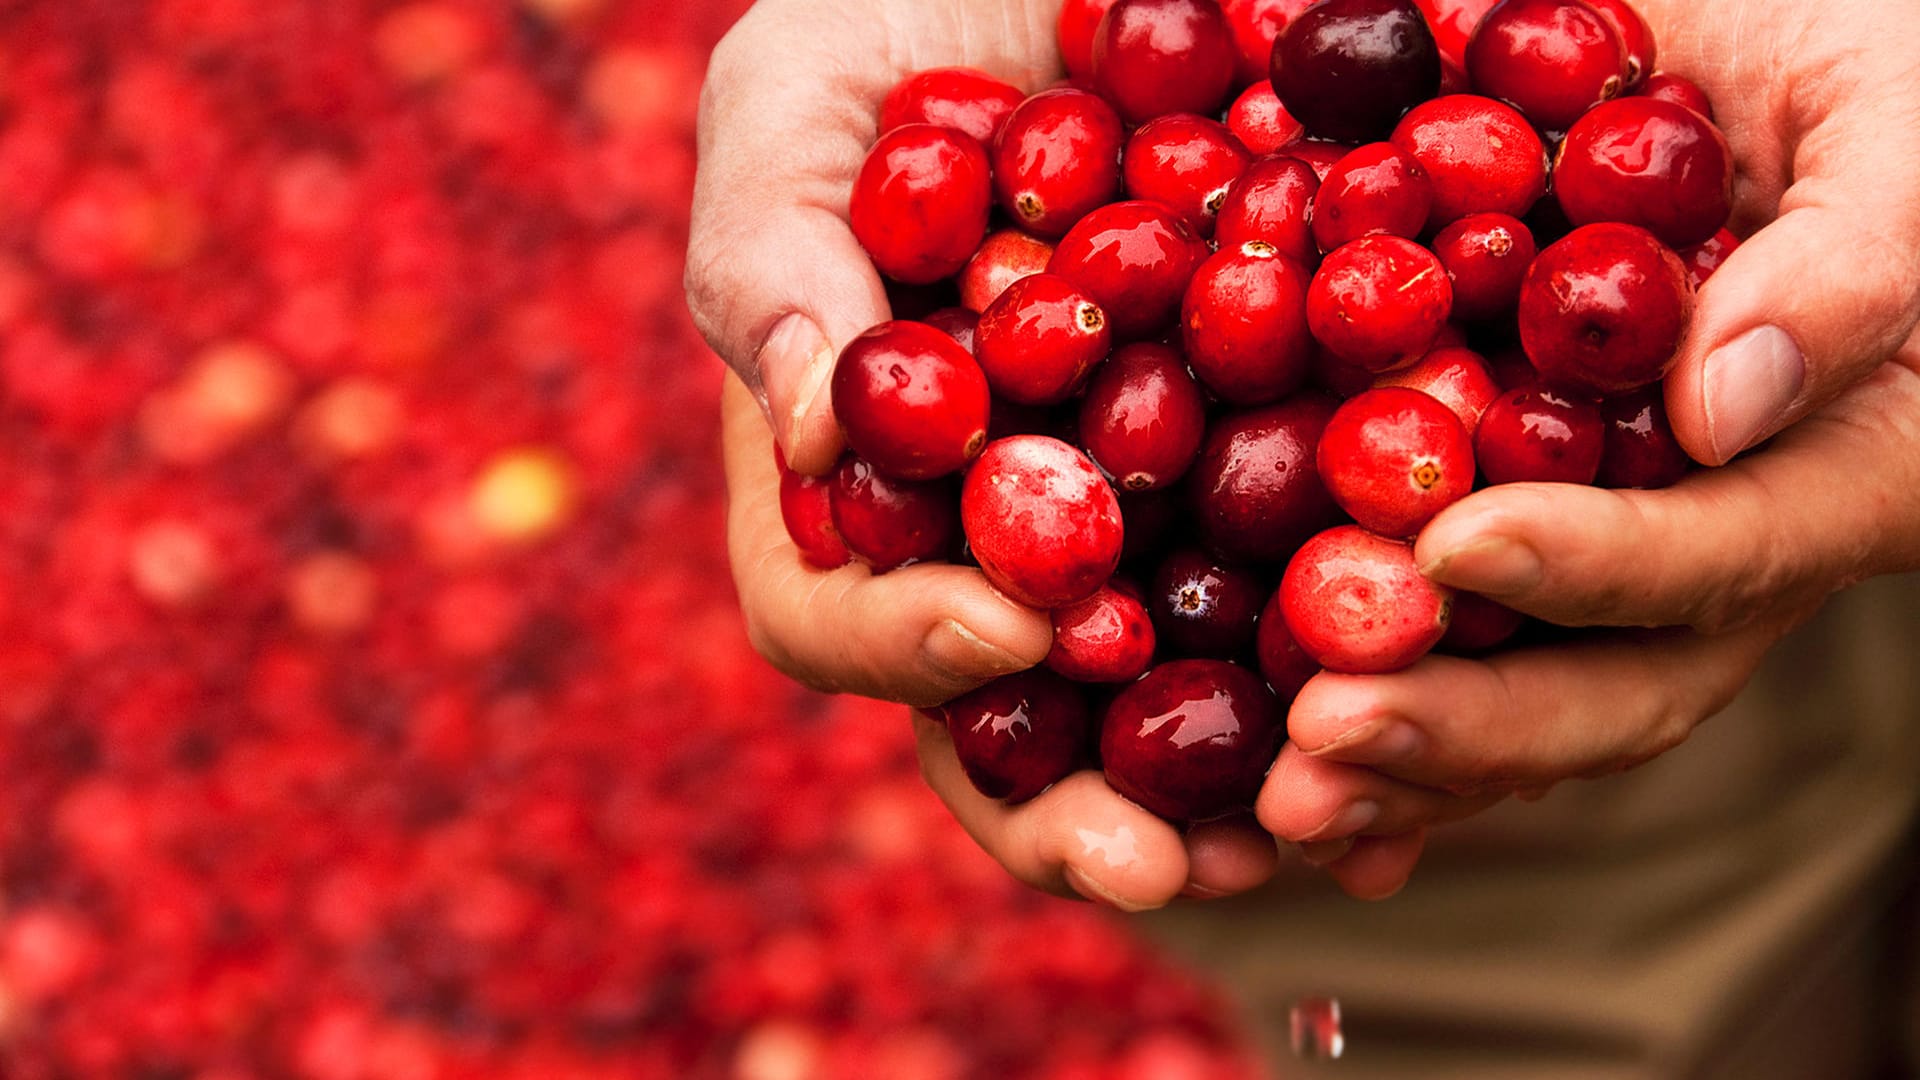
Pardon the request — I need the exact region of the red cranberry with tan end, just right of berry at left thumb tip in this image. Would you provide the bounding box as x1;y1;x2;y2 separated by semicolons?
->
973;273;1114;405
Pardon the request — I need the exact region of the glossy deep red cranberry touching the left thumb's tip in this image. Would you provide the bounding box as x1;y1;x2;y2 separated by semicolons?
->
833;321;989;480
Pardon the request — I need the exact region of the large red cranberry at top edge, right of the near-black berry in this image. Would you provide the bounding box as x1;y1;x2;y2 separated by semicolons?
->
1467;0;1626;131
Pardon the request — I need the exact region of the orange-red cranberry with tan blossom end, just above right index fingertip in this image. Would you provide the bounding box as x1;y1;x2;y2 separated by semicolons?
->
1315;386;1473;538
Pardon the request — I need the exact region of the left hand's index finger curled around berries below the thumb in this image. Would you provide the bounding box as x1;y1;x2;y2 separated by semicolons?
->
722;377;1052;705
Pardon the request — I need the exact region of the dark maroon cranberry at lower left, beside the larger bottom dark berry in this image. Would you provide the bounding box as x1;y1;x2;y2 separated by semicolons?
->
941;669;1092;803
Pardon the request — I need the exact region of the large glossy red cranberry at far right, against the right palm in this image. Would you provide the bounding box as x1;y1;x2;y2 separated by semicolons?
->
1553;98;1734;248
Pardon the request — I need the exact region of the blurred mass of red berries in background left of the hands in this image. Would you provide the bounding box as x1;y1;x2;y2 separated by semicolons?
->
0;0;1256;1080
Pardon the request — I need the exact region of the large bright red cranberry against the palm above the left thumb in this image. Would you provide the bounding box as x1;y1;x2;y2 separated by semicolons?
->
849;123;993;284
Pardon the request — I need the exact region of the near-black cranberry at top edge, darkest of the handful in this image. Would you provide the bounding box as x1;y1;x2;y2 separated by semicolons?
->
1271;0;1440;142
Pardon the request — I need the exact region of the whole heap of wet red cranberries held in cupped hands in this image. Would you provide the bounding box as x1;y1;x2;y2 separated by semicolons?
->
781;0;1736;822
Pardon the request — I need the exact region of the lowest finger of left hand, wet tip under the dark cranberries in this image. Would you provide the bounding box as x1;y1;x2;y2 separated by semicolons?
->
914;711;1188;911
